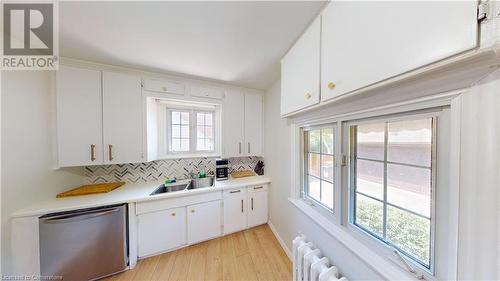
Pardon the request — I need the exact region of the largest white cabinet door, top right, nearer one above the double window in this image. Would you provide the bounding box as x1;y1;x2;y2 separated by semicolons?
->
321;1;478;101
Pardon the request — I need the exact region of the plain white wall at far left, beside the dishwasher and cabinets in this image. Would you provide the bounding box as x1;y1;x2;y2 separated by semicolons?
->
1;71;83;274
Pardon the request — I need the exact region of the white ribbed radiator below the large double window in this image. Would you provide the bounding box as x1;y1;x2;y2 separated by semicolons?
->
293;235;349;281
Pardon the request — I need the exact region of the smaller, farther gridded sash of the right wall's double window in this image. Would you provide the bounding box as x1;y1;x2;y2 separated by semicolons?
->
303;126;335;211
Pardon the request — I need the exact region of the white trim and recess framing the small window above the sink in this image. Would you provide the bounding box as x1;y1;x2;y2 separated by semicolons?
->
158;101;222;160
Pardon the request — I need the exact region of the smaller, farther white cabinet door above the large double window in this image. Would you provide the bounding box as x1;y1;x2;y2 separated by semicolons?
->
281;17;320;115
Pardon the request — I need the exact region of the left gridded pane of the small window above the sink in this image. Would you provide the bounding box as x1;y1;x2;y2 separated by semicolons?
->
170;111;191;152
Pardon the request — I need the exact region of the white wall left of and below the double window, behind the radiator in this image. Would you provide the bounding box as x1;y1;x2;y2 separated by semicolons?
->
264;81;381;280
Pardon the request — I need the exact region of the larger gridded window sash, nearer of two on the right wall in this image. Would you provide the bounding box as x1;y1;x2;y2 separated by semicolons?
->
350;118;435;269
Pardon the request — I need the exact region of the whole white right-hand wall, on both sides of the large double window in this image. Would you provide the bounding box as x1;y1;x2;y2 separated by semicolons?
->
264;70;500;280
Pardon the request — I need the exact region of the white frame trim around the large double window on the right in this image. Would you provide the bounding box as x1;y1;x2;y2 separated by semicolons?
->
289;90;464;280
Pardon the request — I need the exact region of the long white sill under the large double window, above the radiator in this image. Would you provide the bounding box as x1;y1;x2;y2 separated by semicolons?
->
288;198;418;280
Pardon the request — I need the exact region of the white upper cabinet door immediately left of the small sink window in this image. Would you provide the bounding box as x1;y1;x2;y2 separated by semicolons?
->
103;72;143;164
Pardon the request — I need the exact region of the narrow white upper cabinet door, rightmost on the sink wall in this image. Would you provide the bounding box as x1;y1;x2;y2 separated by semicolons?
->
244;94;264;156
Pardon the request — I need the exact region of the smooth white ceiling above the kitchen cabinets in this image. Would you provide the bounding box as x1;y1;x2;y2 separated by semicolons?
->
59;1;324;89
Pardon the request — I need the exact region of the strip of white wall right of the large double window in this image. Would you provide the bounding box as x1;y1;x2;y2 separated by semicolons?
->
458;70;500;280
